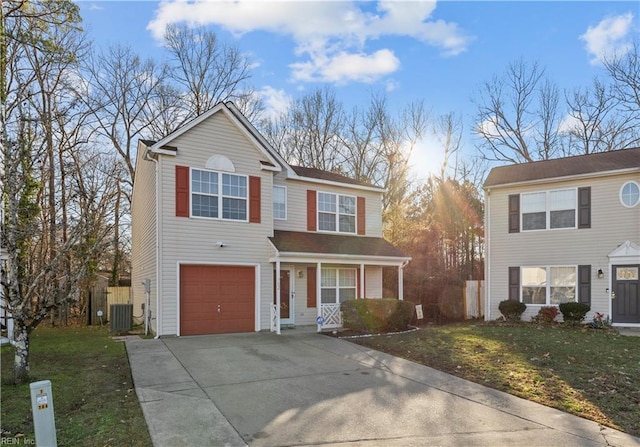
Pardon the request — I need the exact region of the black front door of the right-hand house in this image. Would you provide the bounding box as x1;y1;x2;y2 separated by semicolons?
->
611;265;640;323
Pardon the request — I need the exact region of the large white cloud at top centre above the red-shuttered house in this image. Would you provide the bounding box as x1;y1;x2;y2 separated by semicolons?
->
147;0;469;83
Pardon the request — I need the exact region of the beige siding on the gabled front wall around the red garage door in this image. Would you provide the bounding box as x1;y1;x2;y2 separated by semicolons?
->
160;113;273;335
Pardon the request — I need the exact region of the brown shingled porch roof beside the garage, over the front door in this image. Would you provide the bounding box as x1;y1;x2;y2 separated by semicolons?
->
269;230;410;262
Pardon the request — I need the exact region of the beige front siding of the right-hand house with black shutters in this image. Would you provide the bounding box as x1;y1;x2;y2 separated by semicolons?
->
487;173;640;321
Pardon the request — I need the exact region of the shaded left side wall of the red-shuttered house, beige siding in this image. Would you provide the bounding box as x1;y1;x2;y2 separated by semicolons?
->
131;143;158;333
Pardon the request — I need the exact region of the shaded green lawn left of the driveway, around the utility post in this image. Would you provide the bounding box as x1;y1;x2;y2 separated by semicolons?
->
0;327;152;447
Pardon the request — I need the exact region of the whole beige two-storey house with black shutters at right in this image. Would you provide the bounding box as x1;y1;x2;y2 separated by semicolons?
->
484;148;640;326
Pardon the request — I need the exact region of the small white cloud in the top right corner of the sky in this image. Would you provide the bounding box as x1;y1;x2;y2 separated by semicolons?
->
580;12;633;65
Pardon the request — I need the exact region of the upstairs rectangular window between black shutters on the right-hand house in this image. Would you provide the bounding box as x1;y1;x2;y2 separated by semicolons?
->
521;189;576;231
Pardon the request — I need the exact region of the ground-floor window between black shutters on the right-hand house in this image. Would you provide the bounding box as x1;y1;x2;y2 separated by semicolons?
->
521;266;577;306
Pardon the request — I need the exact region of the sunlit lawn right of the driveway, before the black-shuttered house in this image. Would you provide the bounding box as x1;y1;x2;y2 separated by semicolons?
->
350;323;640;436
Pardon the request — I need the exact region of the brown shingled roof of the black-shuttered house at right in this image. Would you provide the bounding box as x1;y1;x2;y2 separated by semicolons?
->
484;147;640;188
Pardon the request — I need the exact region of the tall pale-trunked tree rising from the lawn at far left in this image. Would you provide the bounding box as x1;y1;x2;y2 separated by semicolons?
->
0;1;115;382
